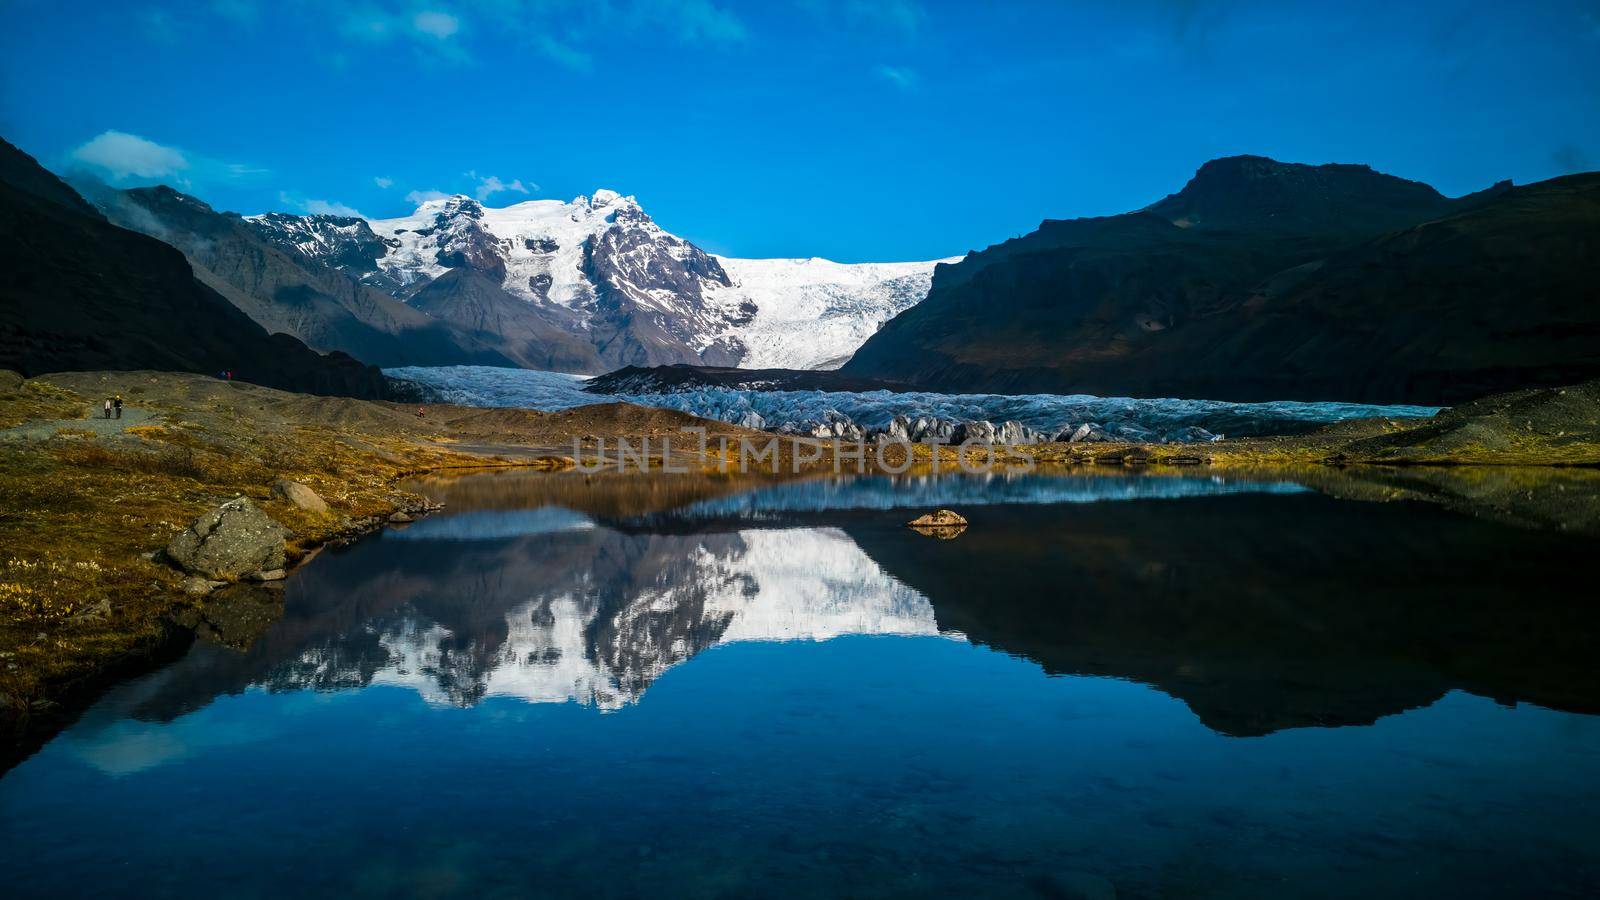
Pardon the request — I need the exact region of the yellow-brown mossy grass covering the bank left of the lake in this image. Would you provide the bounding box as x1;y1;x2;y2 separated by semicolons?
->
0;383;485;721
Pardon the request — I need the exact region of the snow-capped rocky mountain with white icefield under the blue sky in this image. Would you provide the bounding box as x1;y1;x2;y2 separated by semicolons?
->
246;191;936;372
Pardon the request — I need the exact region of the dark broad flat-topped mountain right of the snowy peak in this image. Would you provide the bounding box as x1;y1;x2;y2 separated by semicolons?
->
845;157;1600;404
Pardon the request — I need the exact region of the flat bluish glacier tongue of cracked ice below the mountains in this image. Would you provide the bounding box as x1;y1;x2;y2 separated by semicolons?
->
384;365;1440;440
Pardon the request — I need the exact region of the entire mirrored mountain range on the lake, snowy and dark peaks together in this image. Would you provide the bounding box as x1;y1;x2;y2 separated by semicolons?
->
81;476;1600;735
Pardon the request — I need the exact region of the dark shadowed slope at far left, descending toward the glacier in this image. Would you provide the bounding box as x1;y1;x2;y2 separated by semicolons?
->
0;141;384;397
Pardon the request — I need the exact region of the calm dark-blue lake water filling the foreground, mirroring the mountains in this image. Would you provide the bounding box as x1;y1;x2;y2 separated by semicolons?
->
0;464;1600;897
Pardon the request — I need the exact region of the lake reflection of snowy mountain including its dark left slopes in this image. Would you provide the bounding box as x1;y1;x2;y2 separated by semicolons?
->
84;522;934;721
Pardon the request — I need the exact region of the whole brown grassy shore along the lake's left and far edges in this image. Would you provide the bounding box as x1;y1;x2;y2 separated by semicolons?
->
0;372;1600;759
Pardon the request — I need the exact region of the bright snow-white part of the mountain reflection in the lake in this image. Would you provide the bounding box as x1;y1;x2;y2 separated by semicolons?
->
371;528;939;709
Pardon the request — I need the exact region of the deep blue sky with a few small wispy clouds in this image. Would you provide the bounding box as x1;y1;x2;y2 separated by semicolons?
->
0;0;1600;261
